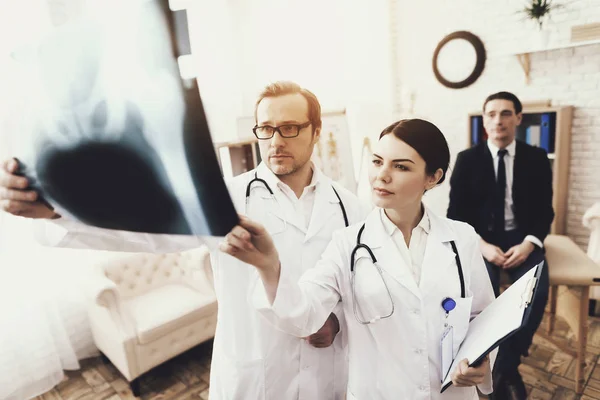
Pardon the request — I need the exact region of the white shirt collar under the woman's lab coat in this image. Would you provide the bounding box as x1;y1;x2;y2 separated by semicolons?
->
381;208;430;286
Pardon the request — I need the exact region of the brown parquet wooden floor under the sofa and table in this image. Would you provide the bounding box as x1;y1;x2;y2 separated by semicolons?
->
36;318;600;400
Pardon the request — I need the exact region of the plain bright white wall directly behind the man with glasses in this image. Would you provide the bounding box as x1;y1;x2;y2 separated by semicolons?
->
199;0;393;178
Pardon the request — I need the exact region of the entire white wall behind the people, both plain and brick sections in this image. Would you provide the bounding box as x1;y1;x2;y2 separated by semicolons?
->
193;0;600;246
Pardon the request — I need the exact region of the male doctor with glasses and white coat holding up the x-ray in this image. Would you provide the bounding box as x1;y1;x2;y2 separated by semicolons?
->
0;82;364;400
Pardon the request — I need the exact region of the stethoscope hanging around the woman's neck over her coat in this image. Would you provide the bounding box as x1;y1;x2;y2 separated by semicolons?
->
350;224;466;325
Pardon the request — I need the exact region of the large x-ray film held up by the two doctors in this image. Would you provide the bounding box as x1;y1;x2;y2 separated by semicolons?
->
18;0;238;236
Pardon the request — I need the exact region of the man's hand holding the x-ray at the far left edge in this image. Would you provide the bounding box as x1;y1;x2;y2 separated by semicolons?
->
0;158;60;219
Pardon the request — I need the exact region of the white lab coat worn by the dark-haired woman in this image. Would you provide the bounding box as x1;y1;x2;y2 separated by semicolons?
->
253;209;495;400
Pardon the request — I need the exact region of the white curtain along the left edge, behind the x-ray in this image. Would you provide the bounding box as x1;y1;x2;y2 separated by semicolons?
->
0;0;106;400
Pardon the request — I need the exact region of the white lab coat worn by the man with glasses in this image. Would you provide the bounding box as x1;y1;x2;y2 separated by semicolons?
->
38;164;365;400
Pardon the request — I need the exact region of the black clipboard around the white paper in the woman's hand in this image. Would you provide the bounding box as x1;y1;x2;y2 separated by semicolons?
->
440;261;544;393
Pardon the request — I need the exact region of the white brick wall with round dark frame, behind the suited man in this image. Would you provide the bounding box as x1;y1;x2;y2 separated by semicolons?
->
390;0;600;249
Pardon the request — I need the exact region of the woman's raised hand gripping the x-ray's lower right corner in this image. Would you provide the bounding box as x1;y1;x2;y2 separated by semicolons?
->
219;215;279;275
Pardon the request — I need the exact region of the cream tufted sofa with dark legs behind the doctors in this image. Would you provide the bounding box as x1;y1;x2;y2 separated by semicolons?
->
89;247;217;396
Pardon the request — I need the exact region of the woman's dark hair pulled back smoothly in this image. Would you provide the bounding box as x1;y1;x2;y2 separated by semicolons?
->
379;119;450;184
